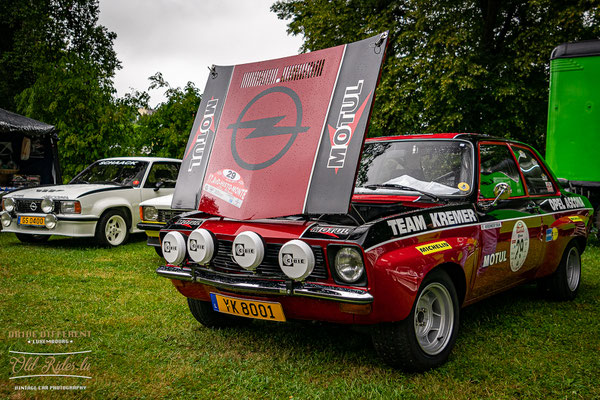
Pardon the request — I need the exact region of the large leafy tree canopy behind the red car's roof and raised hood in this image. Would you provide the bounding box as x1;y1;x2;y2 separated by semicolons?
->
271;0;600;149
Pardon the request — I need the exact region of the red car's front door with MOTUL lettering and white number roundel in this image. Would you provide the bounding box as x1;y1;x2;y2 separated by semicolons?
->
472;142;543;297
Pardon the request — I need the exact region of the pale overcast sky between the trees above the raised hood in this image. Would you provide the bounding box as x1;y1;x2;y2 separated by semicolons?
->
100;0;302;107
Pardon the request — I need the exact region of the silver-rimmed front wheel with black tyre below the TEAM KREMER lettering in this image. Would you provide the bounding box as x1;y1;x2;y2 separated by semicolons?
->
372;269;459;372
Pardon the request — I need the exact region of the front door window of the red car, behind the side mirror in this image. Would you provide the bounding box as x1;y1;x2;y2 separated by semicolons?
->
479;144;525;199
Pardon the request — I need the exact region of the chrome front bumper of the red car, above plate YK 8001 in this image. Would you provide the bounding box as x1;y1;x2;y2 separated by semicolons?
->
156;266;373;304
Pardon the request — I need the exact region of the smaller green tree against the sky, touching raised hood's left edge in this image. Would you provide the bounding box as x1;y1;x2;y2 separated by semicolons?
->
135;72;201;158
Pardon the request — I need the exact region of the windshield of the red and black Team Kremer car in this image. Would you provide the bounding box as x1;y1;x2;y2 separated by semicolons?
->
355;140;473;197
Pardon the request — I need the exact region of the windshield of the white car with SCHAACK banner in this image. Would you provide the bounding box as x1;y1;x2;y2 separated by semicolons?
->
69;160;148;186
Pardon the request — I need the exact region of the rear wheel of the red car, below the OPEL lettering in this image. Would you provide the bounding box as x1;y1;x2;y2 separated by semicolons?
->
538;241;581;301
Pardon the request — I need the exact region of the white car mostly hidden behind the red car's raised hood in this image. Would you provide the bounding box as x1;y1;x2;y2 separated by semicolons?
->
138;194;192;257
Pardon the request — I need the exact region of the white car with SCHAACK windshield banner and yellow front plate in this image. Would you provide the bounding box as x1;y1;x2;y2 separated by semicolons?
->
0;157;181;246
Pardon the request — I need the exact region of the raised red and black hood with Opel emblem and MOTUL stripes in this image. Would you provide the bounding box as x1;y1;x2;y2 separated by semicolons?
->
172;32;387;220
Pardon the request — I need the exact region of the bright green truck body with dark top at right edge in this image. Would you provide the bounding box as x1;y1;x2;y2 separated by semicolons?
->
546;40;600;228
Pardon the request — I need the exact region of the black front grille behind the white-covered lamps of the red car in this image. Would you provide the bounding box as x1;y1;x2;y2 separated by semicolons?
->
210;240;327;280
